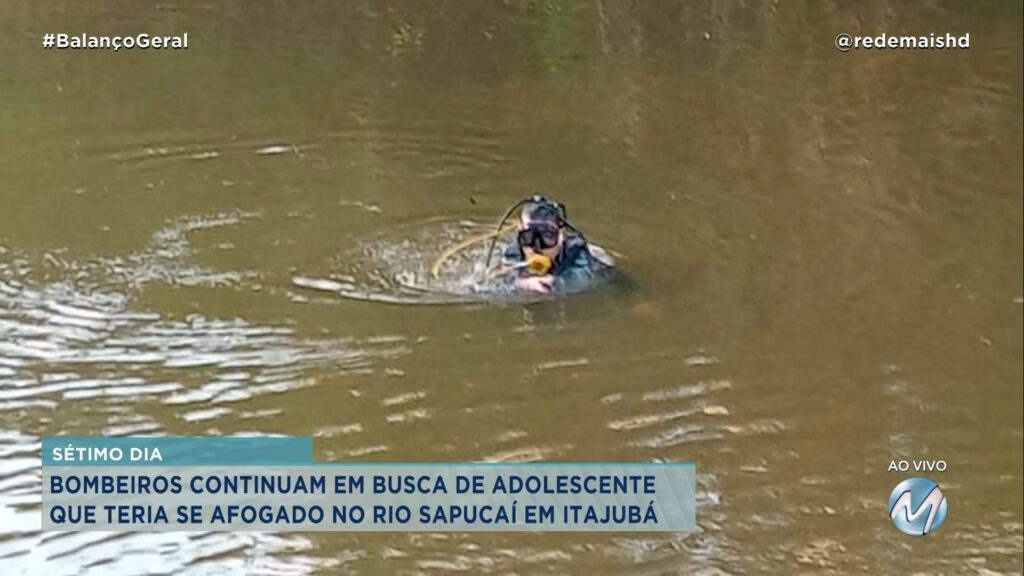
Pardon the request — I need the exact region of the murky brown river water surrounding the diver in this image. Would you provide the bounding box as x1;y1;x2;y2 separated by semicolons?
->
0;0;1024;576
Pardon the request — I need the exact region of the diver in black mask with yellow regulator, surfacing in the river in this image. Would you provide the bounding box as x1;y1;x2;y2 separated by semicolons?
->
486;196;615;294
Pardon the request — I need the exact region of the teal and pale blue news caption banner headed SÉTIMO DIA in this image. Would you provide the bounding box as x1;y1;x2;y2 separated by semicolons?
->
42;437;695;532
